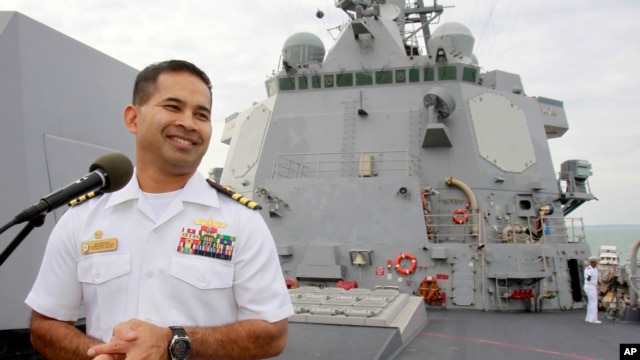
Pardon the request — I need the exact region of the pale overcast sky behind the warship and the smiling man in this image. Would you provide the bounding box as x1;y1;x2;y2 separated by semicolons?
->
0;0;640;225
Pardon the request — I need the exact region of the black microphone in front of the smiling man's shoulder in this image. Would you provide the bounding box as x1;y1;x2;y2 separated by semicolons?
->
0;153;133;233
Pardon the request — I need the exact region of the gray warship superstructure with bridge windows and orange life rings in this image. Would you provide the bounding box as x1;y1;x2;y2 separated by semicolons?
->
220;0;594;311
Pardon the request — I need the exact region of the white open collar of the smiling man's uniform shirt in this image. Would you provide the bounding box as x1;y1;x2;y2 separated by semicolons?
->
105;169;220;208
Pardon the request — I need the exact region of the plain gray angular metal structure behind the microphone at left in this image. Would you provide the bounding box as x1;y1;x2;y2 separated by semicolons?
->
0;11;138;359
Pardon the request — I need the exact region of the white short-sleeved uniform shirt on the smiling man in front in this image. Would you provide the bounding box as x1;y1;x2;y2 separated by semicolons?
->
25;174;293;341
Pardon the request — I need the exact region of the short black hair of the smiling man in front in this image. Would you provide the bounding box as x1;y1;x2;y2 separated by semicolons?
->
132;60;211;105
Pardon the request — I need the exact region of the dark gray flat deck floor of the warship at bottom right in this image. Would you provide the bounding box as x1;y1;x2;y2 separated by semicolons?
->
280;309;640;360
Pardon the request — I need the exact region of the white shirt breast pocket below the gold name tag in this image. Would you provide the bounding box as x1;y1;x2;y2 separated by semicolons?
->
78;253;131;329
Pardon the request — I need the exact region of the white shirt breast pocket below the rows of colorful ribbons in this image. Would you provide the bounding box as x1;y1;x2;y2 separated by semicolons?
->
169;255;237;326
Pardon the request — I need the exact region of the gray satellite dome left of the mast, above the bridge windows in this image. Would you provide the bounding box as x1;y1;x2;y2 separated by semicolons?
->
282;32;324;65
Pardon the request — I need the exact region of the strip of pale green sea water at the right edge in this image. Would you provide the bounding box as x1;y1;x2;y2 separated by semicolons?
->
584;225;640;265
